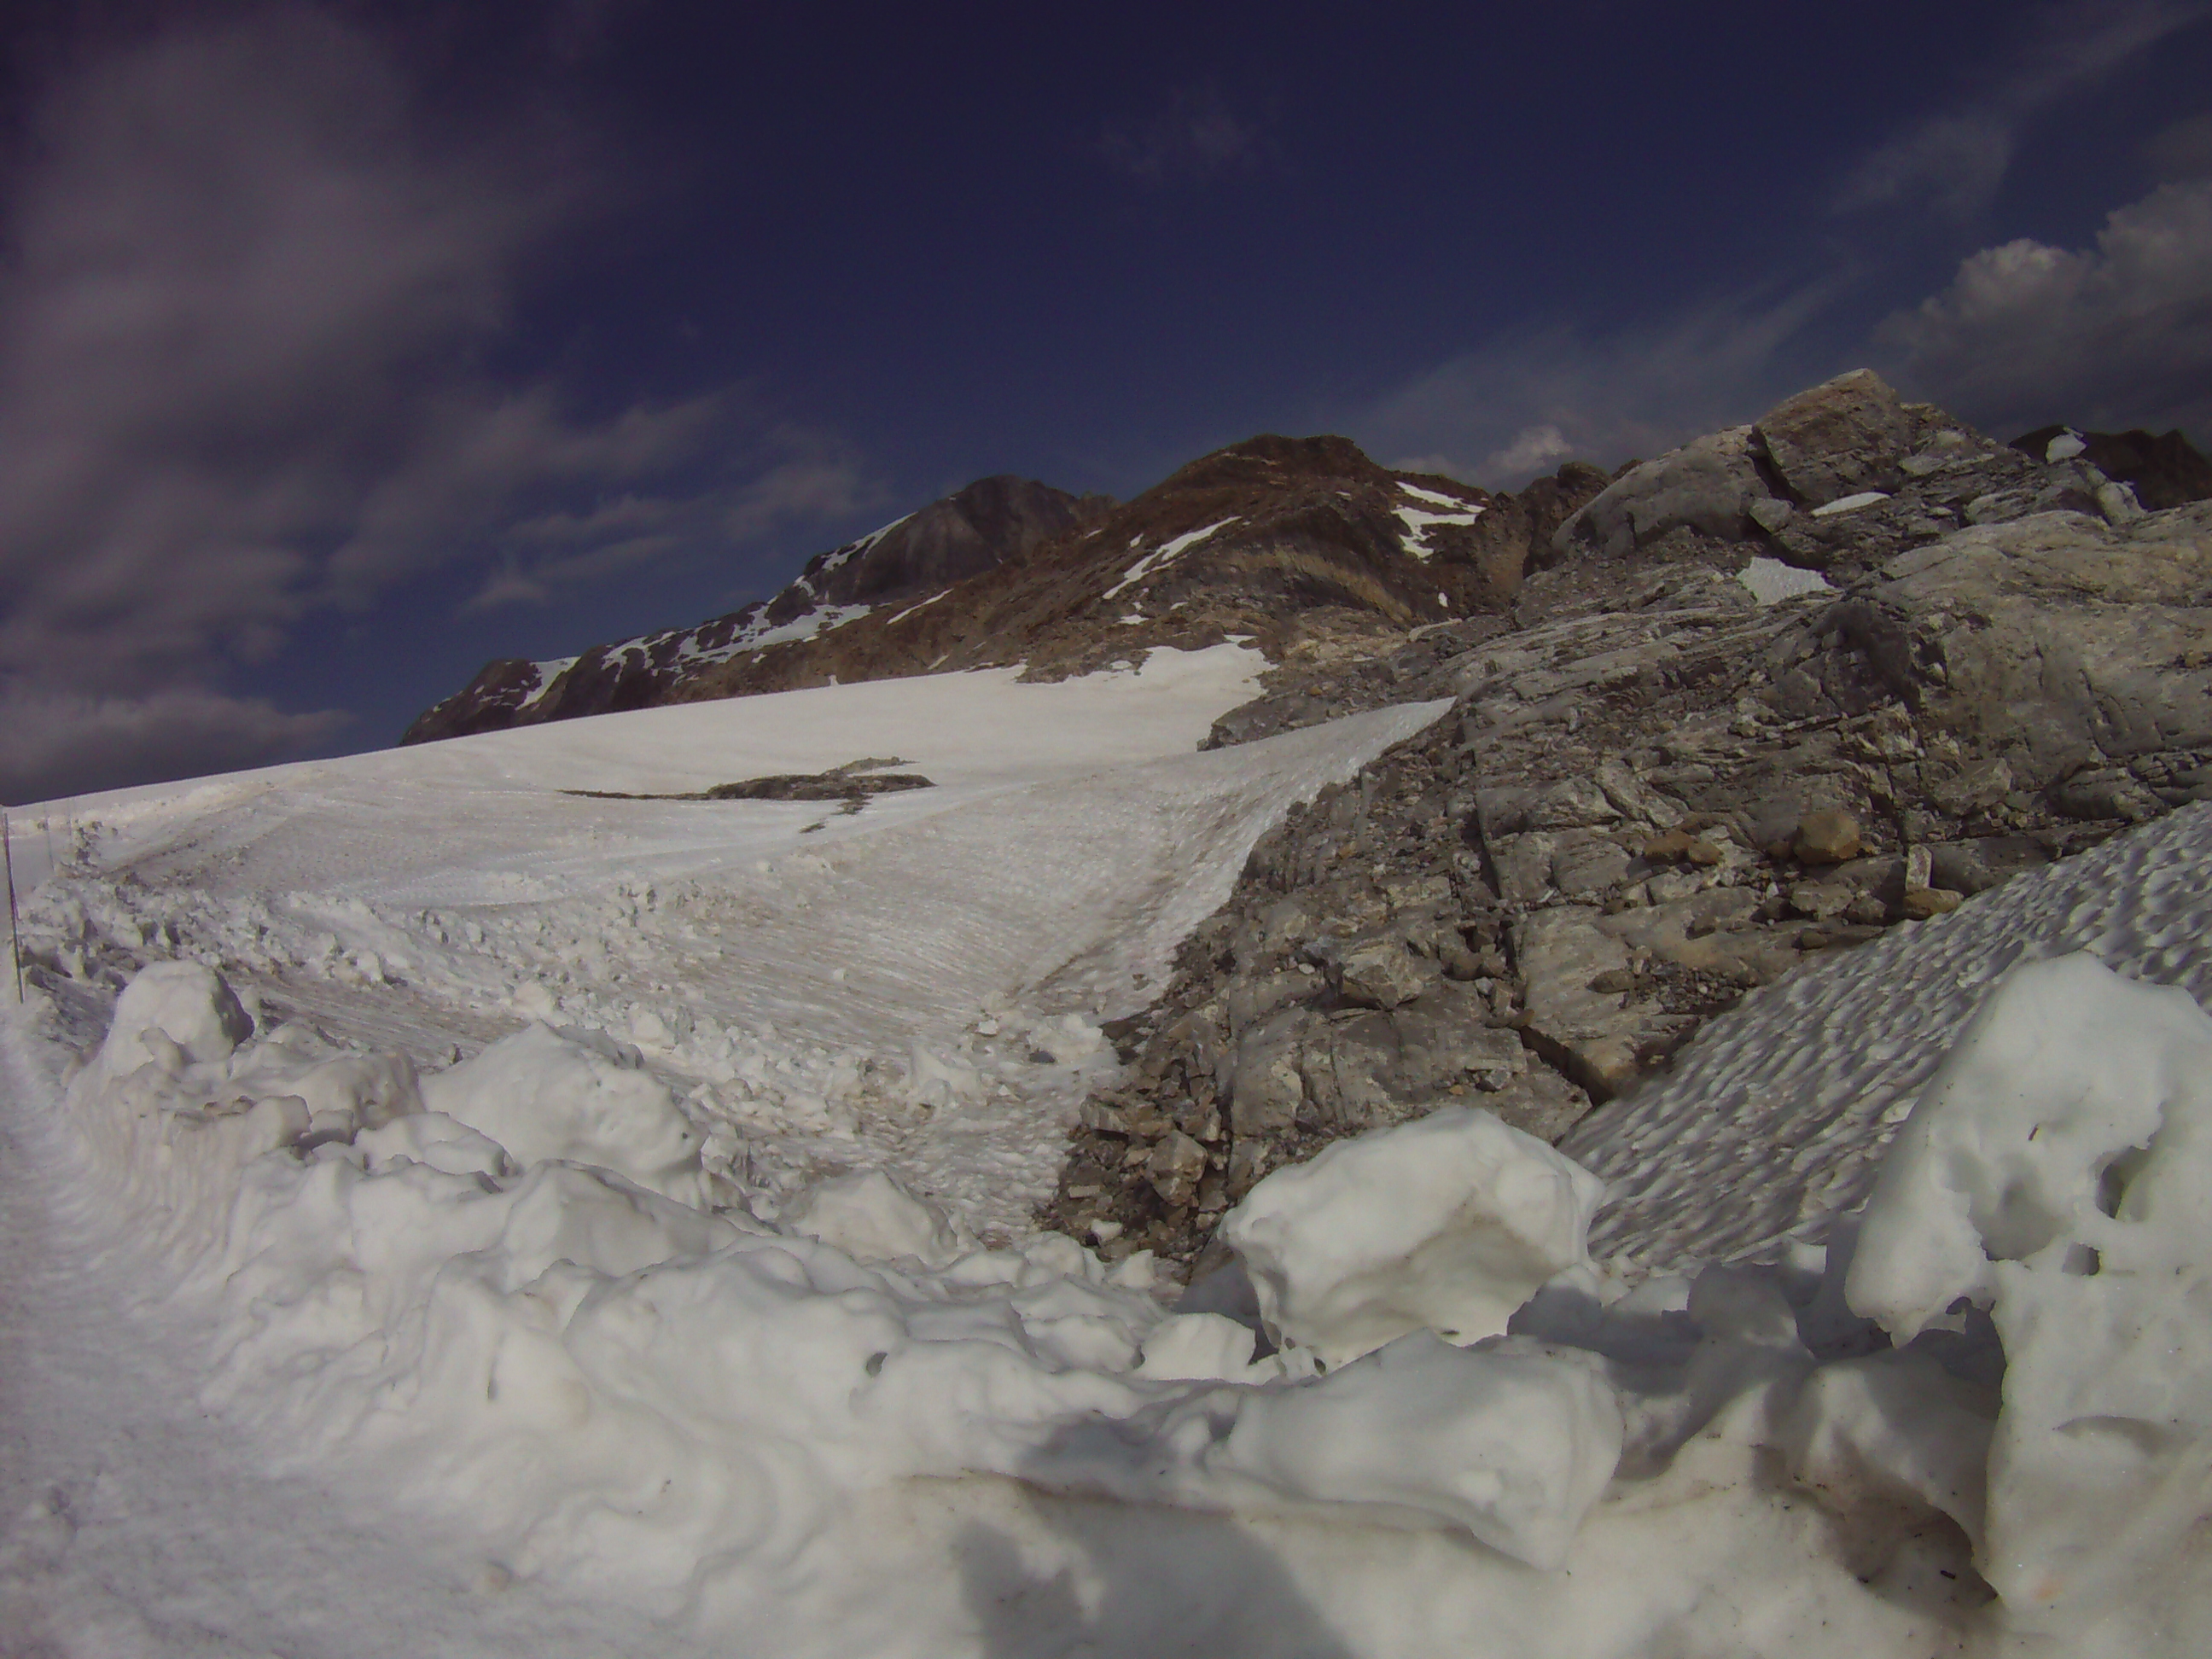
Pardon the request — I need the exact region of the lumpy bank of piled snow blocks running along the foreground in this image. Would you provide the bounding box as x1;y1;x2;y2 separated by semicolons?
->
38;916;2212;1652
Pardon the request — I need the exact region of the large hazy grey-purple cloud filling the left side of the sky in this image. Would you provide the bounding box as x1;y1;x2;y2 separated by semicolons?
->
0;7;867;792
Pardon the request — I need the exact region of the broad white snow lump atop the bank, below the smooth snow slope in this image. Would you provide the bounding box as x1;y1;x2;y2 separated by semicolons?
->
422;1024;703;1203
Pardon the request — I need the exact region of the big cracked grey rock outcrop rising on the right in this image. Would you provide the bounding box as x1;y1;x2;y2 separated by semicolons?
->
1044;376;2212;1263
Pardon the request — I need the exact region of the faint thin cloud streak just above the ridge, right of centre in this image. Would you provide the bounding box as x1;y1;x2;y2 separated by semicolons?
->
1349;274;1847;489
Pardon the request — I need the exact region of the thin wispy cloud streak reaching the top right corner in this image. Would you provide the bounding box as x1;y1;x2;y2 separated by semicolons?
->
1834;0;2212;219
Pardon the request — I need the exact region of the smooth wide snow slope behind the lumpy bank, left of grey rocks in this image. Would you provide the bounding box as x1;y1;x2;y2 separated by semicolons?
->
13;646;1435;1232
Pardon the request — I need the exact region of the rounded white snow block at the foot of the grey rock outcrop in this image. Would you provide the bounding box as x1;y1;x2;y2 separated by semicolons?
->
1221;1106;1606;1365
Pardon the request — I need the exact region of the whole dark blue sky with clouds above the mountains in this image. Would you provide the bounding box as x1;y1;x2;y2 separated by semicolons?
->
0;0;2212;800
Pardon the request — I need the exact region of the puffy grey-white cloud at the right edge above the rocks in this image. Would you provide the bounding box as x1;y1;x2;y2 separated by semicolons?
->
1876;179;2212;438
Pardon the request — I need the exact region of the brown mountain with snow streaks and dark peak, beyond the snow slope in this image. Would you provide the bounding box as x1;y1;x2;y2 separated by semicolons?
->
405;436;1606;743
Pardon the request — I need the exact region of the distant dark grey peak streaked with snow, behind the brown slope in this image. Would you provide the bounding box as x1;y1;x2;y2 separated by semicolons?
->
400;475;1113;743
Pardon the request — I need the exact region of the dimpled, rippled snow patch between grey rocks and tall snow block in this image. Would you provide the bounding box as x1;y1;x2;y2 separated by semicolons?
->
1559;807;2212;1267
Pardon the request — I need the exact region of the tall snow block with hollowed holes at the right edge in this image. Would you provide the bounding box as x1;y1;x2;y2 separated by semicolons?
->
1845;953;2212;1610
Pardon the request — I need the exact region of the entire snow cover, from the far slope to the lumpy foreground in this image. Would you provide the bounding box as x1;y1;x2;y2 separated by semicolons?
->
0;646;2212;1659
